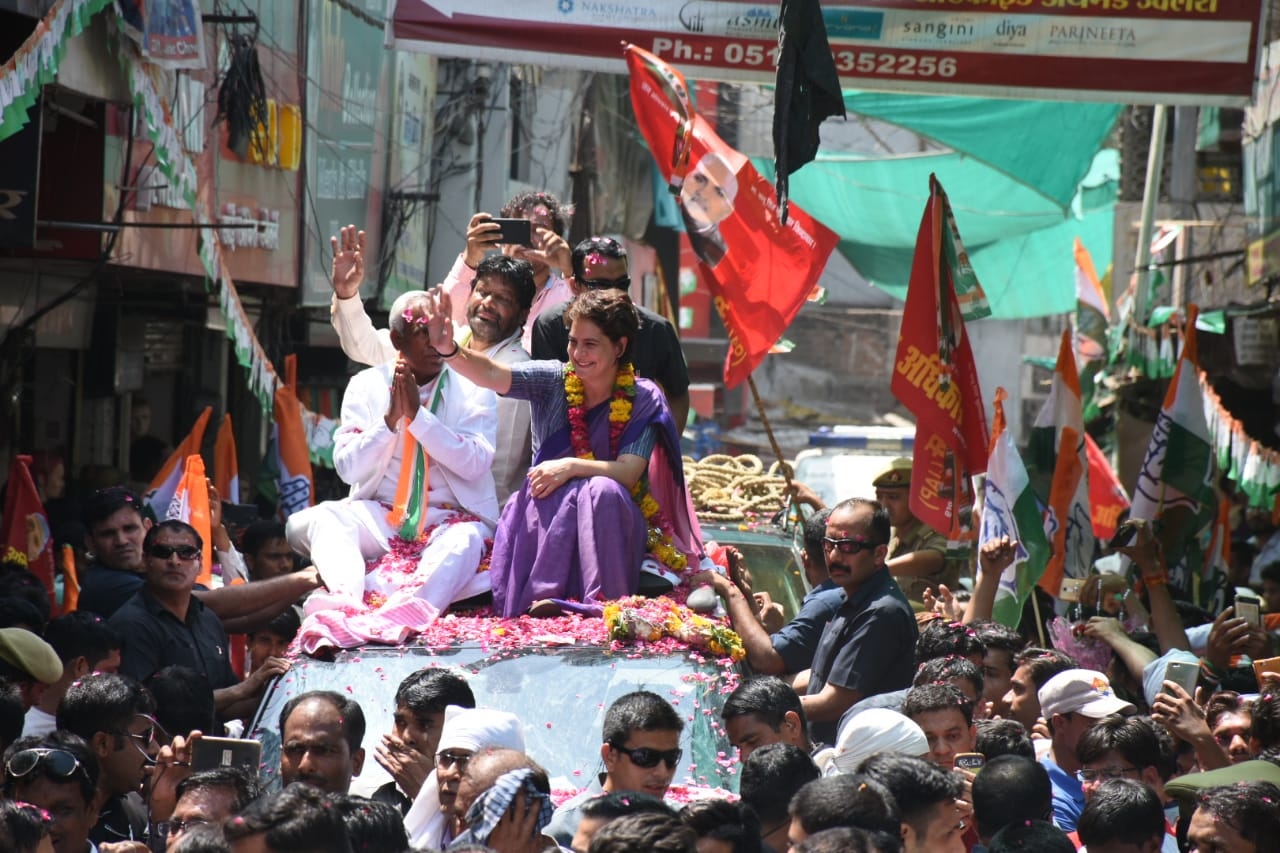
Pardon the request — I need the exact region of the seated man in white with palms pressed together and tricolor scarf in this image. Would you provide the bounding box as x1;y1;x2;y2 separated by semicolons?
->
287;291;498;613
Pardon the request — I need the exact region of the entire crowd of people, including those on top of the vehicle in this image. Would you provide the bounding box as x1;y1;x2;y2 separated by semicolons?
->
0;192;1280;853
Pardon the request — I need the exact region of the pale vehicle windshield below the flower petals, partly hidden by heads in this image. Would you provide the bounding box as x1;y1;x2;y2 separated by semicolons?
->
247;640;737;795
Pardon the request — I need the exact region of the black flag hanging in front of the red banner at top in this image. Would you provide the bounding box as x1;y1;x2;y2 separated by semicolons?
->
773;0;845;223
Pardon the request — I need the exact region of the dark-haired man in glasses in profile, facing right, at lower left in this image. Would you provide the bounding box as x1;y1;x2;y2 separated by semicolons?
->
58;672;156;844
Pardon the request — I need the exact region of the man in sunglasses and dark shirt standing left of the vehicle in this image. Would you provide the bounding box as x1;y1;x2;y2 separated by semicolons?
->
110;520;289;734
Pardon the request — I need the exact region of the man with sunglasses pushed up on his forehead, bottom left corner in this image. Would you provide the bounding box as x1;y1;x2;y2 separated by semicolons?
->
4;731;99;853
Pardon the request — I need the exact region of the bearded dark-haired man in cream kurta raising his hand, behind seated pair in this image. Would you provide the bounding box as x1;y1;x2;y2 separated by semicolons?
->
330;228;536;506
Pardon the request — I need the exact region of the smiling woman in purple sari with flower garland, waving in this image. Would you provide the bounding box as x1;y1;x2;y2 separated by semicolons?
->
417;285;704;616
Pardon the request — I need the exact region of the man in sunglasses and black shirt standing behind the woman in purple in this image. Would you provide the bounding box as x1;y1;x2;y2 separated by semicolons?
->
530;237;689;429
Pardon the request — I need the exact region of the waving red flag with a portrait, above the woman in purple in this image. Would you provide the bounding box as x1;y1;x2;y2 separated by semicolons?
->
626;45;838;388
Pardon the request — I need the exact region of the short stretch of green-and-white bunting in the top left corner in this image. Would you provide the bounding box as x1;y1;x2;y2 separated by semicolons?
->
0;0;110;140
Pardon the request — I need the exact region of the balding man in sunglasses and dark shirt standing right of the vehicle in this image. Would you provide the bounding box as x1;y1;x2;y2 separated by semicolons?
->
795;498;918;744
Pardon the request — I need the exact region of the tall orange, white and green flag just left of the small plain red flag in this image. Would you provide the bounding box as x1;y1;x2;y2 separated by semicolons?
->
1028;329;1094;597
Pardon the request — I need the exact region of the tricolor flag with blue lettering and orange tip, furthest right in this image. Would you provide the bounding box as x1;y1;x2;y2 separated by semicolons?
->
1130;305;1217;580
